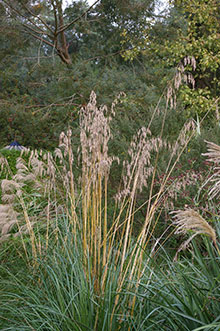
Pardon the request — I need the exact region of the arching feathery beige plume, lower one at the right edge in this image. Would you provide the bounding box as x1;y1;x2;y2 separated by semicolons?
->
171;209;219;261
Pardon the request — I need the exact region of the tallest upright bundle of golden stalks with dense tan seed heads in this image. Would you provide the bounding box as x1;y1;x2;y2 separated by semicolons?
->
80;92;116;293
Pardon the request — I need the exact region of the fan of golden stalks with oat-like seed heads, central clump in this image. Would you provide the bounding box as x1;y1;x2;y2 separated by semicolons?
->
50;92;197;329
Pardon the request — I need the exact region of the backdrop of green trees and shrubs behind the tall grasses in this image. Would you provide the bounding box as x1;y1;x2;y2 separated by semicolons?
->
0;0;220;148
